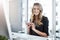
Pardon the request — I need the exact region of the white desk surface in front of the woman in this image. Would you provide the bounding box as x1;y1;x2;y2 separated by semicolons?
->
12;33;52;40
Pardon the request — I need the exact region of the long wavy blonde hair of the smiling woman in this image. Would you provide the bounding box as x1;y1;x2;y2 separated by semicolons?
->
31;3;43;25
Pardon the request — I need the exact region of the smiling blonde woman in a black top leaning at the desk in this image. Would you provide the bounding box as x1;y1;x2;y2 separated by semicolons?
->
27;3;49;37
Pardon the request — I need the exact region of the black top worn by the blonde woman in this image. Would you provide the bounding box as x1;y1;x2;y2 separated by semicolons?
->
30;16;49;36
